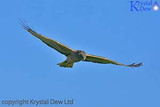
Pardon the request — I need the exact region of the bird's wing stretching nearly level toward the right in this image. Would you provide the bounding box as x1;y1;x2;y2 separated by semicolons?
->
84;55;142;67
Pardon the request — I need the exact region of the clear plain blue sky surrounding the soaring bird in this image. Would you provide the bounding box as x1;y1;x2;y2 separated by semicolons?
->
0;0;160;107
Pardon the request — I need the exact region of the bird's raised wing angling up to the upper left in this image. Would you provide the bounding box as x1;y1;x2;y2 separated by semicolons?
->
21;22;75;56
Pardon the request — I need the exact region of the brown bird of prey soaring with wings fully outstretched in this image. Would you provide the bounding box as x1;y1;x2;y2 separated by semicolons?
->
21;21;142;68
